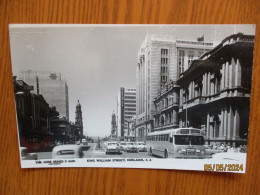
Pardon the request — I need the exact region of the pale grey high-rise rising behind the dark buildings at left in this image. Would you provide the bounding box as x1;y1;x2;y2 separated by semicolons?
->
18;70;69;120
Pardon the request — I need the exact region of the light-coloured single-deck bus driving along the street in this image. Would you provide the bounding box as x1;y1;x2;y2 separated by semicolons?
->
147;128;206;158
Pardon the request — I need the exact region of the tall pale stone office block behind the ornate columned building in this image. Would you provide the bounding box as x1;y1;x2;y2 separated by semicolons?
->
136;35;213;140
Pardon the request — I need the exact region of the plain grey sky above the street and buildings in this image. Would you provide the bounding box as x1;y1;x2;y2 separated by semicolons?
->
10;24;255;136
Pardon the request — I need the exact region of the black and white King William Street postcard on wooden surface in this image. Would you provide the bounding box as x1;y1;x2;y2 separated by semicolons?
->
9;24;255;173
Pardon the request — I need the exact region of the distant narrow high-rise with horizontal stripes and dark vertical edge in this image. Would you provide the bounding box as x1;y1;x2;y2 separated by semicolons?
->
117;87;136;138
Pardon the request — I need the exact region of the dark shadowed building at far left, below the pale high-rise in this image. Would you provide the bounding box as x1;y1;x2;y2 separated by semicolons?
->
13;76;59;150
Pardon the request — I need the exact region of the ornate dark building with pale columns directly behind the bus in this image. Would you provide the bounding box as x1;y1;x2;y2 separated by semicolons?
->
178;33;254;146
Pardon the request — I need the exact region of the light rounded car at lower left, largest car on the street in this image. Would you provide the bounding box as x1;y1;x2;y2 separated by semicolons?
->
52;144;84;159
